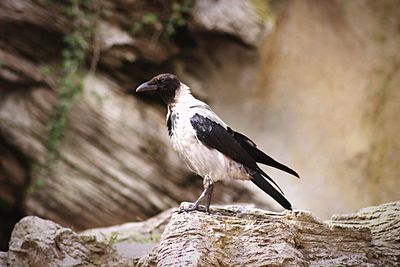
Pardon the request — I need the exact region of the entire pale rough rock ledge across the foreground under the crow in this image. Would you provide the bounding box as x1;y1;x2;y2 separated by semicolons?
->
2;202;400;266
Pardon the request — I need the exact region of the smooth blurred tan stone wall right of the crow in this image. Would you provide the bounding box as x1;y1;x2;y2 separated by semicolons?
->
187;0;400;219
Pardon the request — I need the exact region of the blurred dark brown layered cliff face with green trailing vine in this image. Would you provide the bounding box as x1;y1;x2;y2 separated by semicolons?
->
0;0;264;237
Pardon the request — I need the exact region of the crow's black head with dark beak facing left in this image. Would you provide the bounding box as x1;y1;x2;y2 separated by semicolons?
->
136;73;181;104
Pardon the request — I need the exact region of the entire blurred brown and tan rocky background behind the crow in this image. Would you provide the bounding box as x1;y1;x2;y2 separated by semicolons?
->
0;0;400;250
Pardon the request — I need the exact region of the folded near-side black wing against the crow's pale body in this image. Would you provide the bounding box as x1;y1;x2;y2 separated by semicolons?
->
190;114;283;197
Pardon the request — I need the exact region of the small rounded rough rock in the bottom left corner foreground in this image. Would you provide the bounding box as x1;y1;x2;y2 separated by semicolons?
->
7;216;118;266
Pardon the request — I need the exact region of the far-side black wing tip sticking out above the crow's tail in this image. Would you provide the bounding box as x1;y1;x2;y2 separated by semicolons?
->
228;127;300;178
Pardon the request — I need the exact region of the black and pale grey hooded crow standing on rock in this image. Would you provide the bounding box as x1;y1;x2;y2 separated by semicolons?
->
136;73;300;213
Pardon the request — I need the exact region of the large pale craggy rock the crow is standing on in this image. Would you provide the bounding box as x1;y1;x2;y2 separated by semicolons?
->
157;202;400;266
